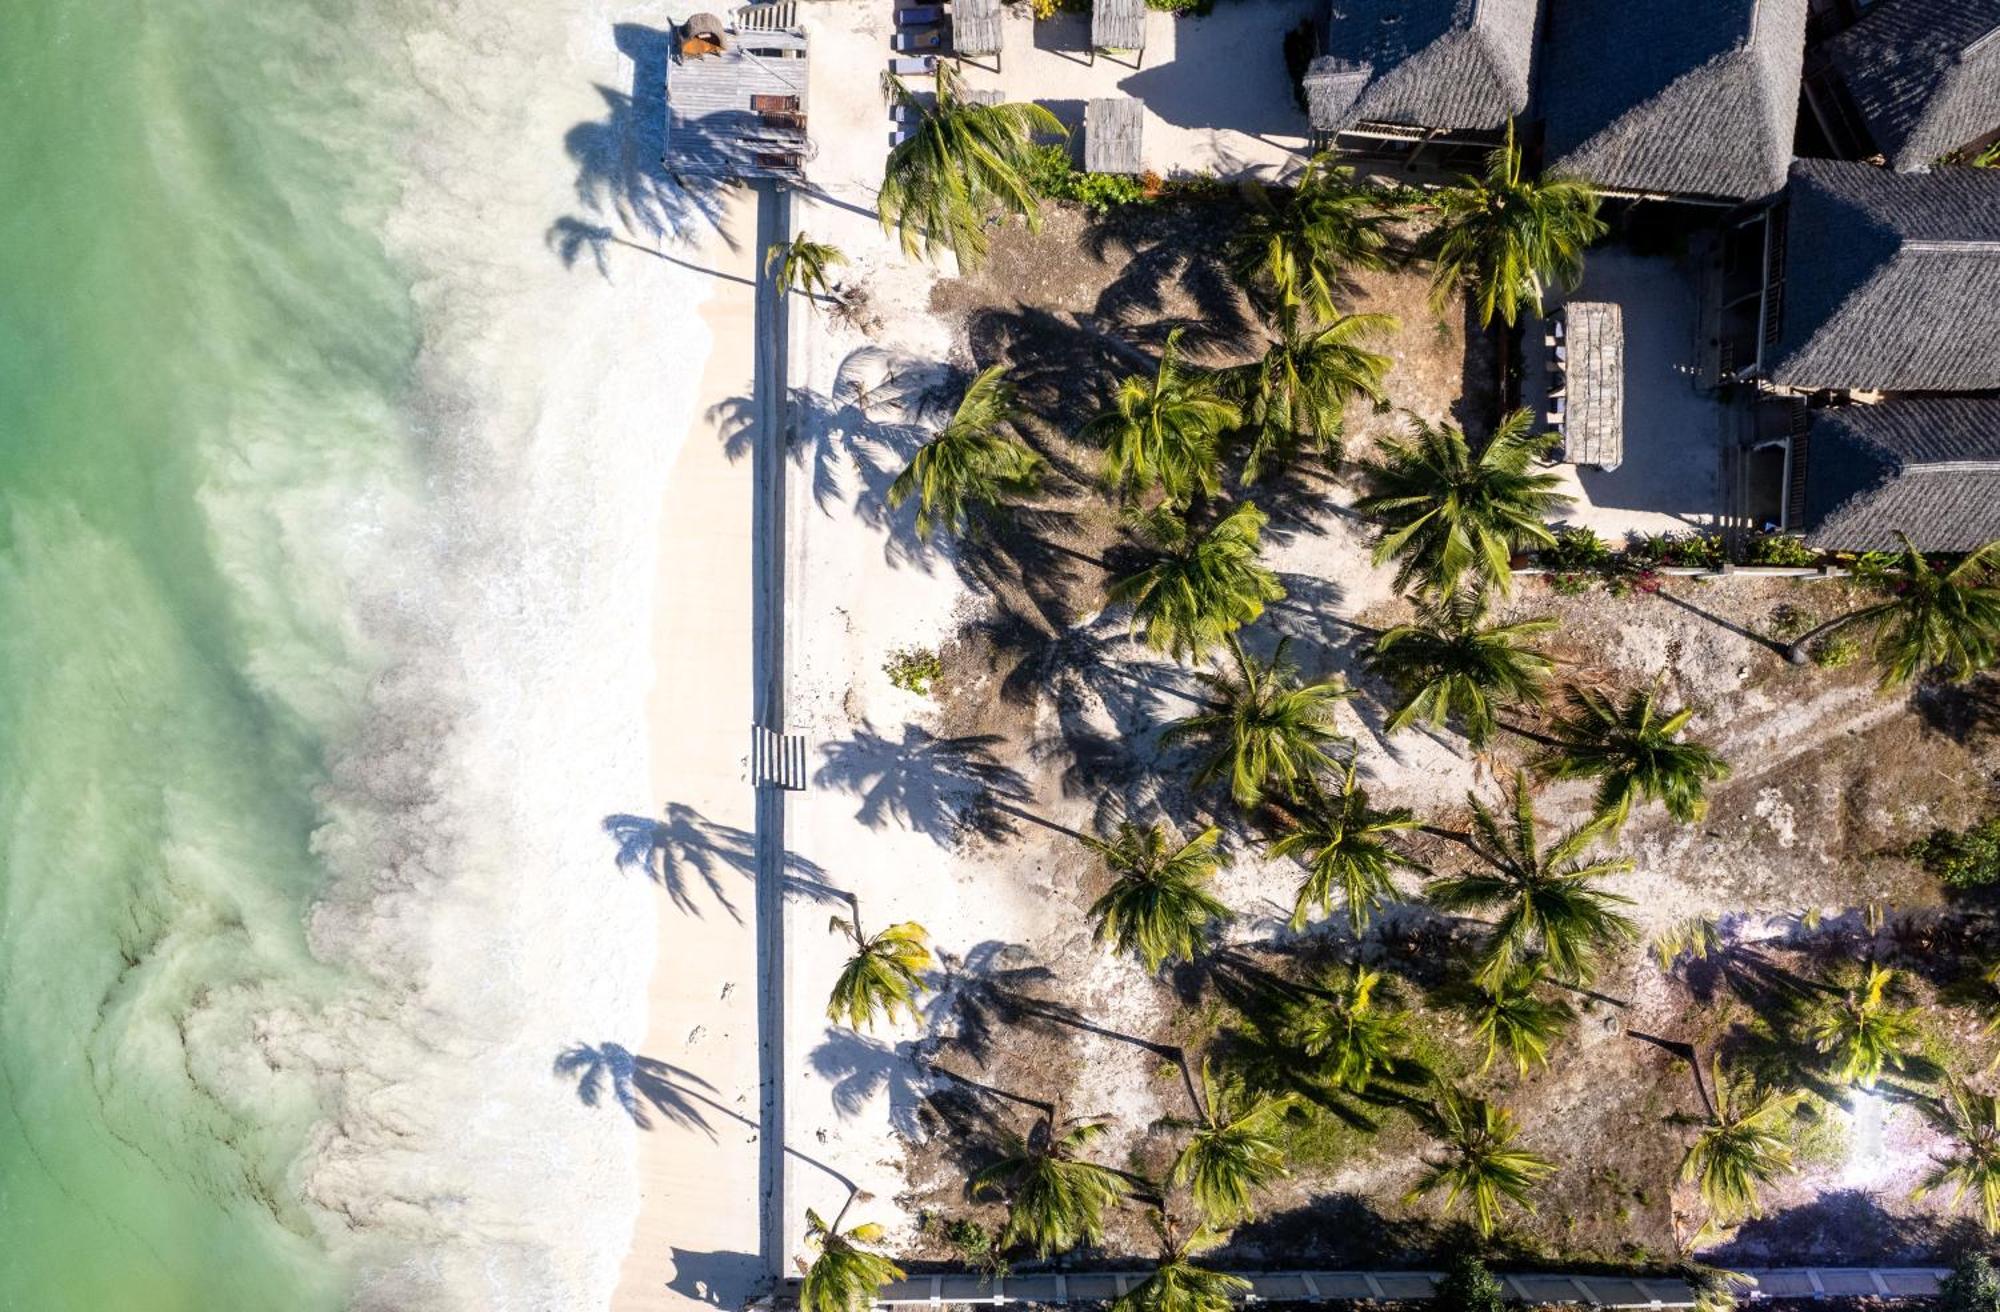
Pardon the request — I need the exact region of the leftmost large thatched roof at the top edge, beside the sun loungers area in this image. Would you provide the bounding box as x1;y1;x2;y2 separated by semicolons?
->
1306;0;1536;132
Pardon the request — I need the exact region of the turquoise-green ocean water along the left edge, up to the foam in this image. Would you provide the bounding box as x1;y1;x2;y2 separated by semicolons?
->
0;0;416;1312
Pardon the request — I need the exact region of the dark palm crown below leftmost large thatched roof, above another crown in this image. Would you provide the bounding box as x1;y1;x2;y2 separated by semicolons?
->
1230;154;1394;318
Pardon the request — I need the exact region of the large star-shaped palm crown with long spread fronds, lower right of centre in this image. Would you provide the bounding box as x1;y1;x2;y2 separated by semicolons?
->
1424;770;1638;984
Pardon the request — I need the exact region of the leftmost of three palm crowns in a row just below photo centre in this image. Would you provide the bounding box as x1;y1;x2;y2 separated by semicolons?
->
1084;820;1230;970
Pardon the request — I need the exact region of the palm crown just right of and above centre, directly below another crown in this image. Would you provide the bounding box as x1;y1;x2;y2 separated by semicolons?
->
1108;502;1284;660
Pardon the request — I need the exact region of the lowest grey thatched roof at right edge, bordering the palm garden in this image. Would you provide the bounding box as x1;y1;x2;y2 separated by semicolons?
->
1794;396;2000;552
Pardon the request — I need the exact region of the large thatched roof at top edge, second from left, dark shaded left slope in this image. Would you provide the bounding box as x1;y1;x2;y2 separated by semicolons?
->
1540;0;1806;202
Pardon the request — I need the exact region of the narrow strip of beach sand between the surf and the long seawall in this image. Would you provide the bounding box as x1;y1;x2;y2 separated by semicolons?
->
612;192;762;1308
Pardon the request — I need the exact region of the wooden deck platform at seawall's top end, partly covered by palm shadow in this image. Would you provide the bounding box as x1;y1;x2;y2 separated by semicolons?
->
664;4;812;182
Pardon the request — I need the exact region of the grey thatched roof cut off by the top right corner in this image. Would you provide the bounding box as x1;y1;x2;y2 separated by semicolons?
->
1826;0;2000;170
